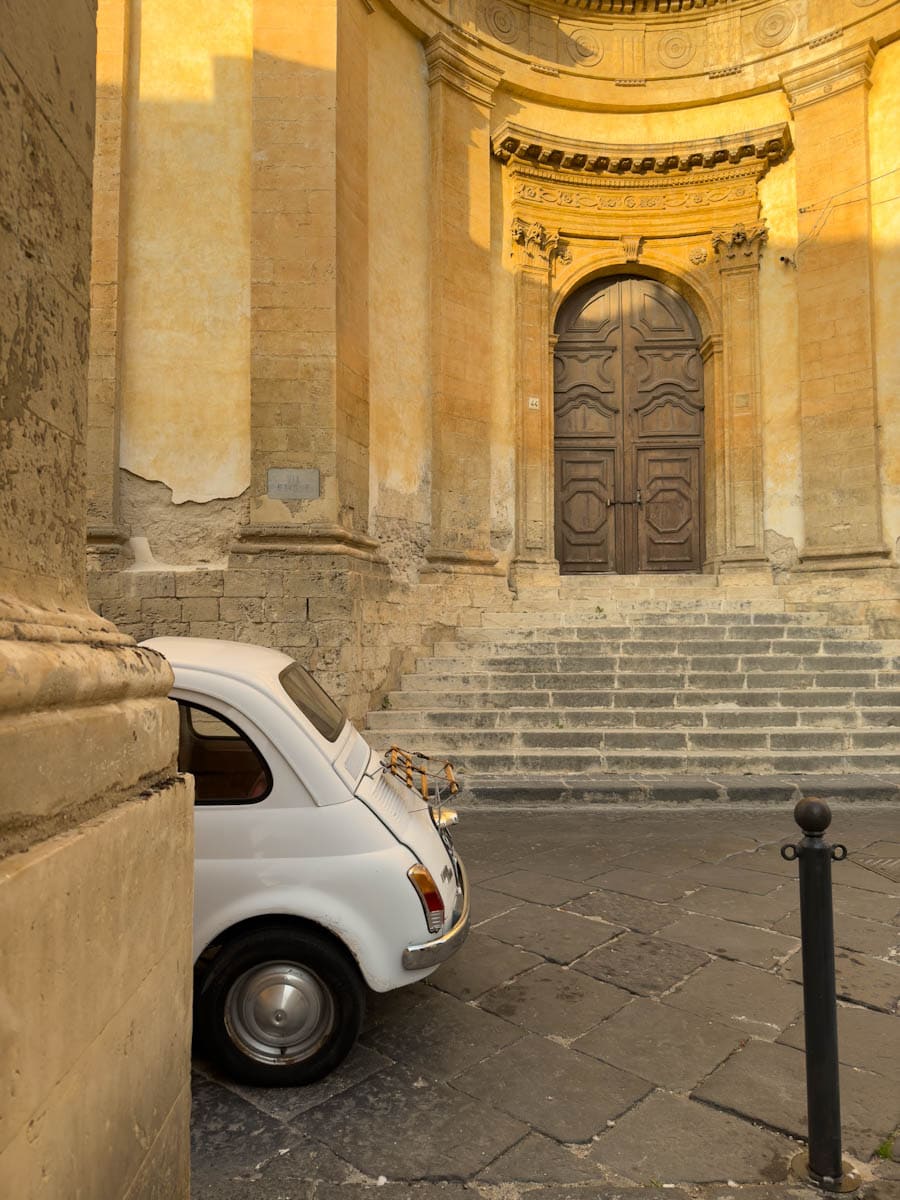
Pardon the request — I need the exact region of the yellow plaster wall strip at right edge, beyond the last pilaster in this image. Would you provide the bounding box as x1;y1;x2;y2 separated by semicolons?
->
869;42;900;559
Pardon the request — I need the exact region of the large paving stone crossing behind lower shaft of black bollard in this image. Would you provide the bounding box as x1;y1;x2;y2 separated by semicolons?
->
694;1040;900;1159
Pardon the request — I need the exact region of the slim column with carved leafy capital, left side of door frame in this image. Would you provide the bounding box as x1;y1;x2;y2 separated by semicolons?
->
511;217;570;588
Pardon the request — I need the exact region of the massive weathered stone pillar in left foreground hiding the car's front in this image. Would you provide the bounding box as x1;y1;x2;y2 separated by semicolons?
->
0;0;193;1200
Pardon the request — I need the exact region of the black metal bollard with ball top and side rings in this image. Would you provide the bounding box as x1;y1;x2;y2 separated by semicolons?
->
781;799;860;1192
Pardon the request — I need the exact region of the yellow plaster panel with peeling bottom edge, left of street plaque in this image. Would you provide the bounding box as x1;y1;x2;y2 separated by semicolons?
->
120;0;253;504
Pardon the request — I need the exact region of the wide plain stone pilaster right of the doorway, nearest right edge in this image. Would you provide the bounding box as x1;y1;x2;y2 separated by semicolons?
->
782;43;888;569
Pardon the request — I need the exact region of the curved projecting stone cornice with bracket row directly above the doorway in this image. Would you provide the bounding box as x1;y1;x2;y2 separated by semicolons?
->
491;121;792;176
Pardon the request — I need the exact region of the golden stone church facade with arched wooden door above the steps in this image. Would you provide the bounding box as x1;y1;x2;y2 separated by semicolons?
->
89;0;900;716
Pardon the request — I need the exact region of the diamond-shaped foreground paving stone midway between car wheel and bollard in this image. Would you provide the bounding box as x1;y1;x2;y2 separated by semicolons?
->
453;1037;648;1141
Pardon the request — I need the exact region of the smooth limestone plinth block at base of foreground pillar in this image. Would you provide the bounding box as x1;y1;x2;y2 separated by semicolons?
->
0;780;193;1200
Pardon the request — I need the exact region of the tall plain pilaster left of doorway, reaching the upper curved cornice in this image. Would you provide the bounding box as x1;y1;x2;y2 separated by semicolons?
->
425;34;500;572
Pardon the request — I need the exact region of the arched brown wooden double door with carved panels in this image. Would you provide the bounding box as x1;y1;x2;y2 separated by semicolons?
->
553;277;703;575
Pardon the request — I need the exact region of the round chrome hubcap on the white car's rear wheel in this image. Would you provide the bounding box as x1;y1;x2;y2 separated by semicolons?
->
224;962;335;1066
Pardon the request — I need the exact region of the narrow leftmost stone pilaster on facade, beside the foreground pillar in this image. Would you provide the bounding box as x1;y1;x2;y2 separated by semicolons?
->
88;0;131;552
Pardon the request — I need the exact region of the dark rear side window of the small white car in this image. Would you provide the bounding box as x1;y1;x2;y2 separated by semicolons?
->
178;700;272;804
